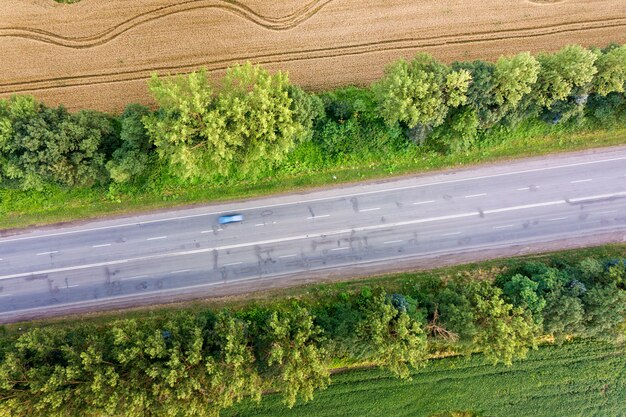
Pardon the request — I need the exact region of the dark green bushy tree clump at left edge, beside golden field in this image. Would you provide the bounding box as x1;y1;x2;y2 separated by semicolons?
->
0;96;113;190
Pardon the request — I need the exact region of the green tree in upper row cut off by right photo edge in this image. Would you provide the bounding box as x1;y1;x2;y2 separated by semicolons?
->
593;45;626;96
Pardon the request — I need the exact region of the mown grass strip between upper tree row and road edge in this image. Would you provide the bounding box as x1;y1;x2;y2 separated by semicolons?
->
0;123;626;229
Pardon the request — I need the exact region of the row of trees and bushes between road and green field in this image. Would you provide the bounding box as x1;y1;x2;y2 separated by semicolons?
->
0;255;626;417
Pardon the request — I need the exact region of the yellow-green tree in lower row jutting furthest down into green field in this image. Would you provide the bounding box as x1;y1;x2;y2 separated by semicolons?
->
263;305;330;408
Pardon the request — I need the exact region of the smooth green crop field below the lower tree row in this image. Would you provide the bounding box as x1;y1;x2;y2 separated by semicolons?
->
223;340;626;417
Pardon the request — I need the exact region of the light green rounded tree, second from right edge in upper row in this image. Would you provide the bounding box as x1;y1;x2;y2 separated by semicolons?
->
533;45;597;108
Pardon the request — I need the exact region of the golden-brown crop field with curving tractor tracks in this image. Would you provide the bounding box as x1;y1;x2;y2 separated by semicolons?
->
0;0;626;111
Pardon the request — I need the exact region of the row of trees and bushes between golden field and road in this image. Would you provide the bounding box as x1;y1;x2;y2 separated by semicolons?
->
0;45;626;201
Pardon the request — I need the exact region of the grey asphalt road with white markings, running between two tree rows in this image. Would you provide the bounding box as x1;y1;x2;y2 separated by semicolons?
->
0;147;626;321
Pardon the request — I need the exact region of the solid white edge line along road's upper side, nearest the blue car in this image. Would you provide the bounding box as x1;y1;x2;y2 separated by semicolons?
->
0;156;626;244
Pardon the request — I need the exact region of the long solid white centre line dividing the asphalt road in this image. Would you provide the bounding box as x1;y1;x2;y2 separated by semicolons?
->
0;191;626;280
